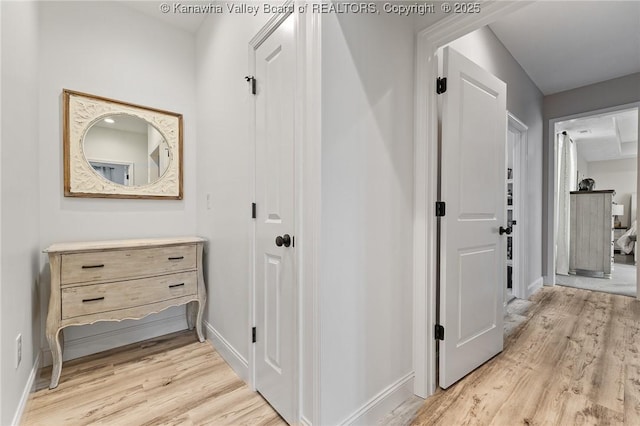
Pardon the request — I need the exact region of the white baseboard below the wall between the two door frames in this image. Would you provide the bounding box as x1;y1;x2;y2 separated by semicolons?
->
340;371;415;425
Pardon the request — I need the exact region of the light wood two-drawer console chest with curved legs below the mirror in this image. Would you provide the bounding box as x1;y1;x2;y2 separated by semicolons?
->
45;237;207;389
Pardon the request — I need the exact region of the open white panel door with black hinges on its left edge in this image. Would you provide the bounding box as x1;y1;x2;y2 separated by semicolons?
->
439;48;507;388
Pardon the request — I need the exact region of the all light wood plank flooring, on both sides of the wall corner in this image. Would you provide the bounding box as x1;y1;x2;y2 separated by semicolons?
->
23;287;640;426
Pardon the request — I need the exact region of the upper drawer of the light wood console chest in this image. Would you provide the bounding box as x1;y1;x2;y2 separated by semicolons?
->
60;245;196;286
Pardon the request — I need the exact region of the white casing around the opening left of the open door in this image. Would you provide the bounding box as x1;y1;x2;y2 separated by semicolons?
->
413;1;531;398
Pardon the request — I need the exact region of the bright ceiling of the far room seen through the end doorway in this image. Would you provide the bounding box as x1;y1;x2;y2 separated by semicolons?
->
556;108;638;162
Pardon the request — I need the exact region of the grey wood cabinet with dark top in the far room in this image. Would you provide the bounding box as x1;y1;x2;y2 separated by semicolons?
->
569;190;615;278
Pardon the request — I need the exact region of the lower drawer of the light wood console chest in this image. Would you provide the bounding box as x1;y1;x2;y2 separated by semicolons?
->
62;271;198;319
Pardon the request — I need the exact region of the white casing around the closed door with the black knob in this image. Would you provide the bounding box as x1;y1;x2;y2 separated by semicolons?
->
247;5;321;424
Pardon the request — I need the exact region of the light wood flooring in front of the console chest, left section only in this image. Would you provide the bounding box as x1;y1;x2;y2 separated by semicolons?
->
22;332;286;426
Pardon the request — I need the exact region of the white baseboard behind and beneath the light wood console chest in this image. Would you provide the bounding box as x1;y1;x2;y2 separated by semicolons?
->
42;314;187;366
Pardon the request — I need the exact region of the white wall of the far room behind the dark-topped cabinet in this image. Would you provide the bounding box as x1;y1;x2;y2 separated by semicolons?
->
589;158;638;227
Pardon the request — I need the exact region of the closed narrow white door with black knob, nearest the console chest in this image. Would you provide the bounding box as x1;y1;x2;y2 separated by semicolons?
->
255;15;297;423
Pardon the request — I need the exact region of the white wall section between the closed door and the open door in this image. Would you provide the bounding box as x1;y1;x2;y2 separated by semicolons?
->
319;14;414;424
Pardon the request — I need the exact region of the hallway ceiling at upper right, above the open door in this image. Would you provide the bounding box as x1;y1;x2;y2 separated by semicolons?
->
489;0;640;95
